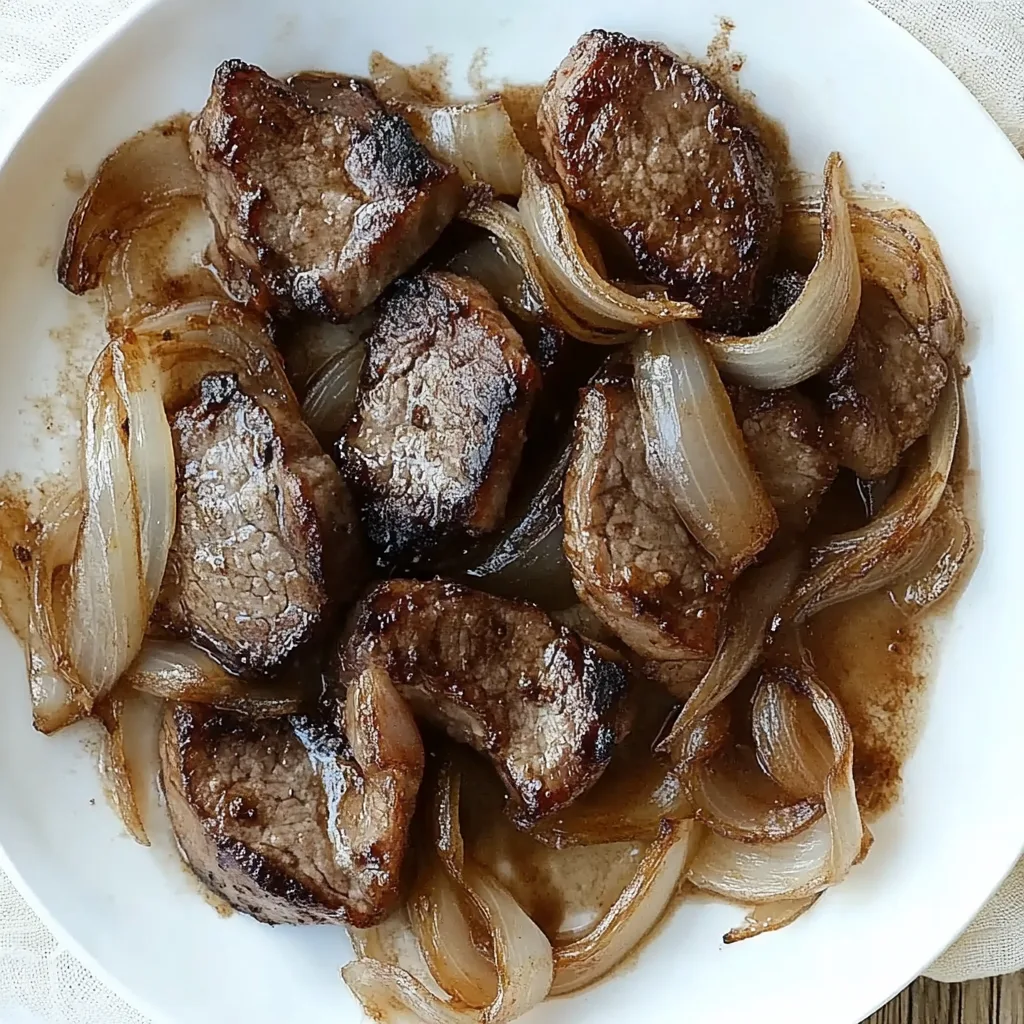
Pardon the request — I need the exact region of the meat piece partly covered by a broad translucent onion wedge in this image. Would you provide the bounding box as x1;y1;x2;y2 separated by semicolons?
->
564;379;724;664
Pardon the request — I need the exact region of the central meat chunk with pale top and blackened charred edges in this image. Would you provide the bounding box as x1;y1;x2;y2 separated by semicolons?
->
341;271;541;558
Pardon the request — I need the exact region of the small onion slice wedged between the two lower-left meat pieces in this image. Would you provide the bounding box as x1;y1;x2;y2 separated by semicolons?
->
123;638;302;718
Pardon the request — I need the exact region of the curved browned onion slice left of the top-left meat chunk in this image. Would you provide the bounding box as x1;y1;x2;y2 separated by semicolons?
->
57;114;203;294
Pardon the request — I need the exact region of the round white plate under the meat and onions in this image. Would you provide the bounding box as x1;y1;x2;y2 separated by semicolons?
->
0;0;1024;1024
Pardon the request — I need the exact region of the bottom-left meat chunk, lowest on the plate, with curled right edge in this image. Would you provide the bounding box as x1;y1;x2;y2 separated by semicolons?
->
160;670;423;928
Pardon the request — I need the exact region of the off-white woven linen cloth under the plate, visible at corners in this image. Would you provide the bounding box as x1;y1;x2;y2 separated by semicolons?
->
0;0;1024;1024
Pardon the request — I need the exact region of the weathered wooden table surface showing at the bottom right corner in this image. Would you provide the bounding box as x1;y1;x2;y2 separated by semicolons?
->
864;971;1024;1024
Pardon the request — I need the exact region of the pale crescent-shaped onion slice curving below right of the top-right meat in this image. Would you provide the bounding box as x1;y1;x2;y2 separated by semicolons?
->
707;153;860;390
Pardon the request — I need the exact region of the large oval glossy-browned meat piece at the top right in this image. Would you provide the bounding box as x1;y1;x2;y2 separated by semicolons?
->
539;31;780;329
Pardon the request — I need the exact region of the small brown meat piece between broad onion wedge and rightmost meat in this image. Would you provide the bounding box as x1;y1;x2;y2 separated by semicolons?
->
730;387;839;532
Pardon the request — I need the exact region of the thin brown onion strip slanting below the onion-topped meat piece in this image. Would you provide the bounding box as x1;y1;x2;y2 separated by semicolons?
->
658;552;801;764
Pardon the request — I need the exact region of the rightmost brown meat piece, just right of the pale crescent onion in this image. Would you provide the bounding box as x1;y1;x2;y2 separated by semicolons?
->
822;282;948;478
